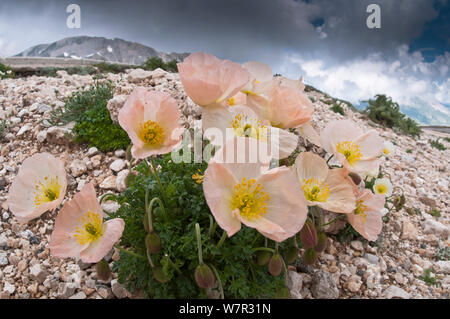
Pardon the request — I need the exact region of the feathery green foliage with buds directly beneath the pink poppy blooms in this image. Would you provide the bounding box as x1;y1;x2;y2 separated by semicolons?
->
110;154;292;299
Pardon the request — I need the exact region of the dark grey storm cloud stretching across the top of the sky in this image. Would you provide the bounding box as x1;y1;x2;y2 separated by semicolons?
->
0;0;437;62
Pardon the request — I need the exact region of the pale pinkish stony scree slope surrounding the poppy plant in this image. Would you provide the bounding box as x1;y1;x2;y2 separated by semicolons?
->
0;69;450;299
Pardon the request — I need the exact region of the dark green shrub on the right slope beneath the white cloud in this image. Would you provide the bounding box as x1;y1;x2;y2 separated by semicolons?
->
364;94;422;136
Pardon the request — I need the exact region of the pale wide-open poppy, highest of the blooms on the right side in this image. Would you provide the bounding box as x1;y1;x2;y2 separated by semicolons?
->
320;120;384;175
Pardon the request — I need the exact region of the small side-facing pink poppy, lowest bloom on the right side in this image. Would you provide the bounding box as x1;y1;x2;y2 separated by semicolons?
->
347;189;386;241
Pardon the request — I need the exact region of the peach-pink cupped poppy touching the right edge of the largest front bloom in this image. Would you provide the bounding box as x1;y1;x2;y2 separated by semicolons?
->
295;152;355;213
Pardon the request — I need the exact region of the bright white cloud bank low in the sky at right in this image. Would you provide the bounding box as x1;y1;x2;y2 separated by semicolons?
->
281;45;450;125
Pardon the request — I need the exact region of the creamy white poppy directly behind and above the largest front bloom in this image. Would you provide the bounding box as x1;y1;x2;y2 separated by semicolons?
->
202;105;298;159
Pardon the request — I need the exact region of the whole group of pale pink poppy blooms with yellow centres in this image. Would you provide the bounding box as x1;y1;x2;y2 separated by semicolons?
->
8;53;392;270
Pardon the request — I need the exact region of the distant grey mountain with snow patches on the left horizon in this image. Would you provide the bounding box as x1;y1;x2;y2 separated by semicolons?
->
16;36;188;64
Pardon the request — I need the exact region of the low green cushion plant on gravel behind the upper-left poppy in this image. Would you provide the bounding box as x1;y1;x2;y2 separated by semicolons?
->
49;82;130;152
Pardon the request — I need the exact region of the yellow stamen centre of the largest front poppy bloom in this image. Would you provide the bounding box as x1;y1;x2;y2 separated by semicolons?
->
231;177;270;220
